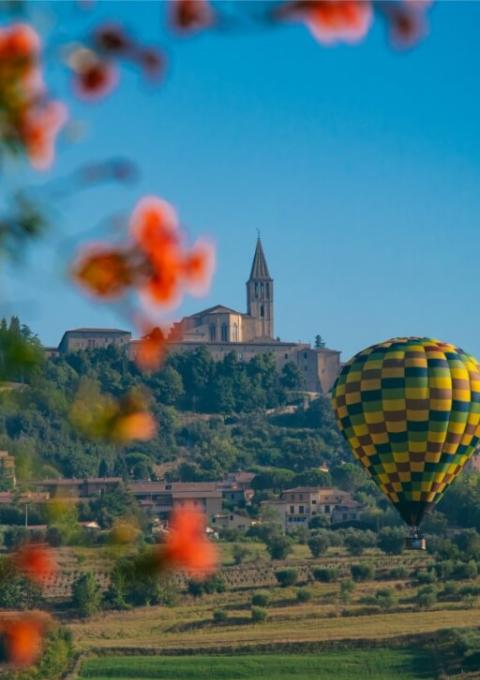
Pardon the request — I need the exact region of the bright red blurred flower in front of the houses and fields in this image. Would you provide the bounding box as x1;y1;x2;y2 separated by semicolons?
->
161;505;218;578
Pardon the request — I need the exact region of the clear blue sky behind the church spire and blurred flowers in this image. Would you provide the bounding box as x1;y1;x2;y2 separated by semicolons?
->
2;1;480;359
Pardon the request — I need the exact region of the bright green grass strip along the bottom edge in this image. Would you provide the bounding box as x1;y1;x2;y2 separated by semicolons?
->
79;649;436;680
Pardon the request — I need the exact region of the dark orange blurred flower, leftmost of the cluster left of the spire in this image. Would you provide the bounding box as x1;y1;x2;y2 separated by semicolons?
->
73;246;132;298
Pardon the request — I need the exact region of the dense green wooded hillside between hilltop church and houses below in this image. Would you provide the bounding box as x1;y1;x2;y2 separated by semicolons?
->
0;322;350;479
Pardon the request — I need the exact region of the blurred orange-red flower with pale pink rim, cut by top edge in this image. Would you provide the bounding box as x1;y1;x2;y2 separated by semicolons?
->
277;0;373;45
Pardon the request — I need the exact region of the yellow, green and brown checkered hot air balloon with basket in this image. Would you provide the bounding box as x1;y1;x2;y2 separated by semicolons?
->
332;337;480;548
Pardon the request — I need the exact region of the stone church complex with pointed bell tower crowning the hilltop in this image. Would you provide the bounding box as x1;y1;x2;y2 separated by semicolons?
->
53;239;340;394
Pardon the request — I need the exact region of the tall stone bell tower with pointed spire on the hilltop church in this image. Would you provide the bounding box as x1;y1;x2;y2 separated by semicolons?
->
247;237;273;339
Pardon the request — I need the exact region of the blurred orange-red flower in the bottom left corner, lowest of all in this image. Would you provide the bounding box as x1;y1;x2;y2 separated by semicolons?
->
0;614;45;666
